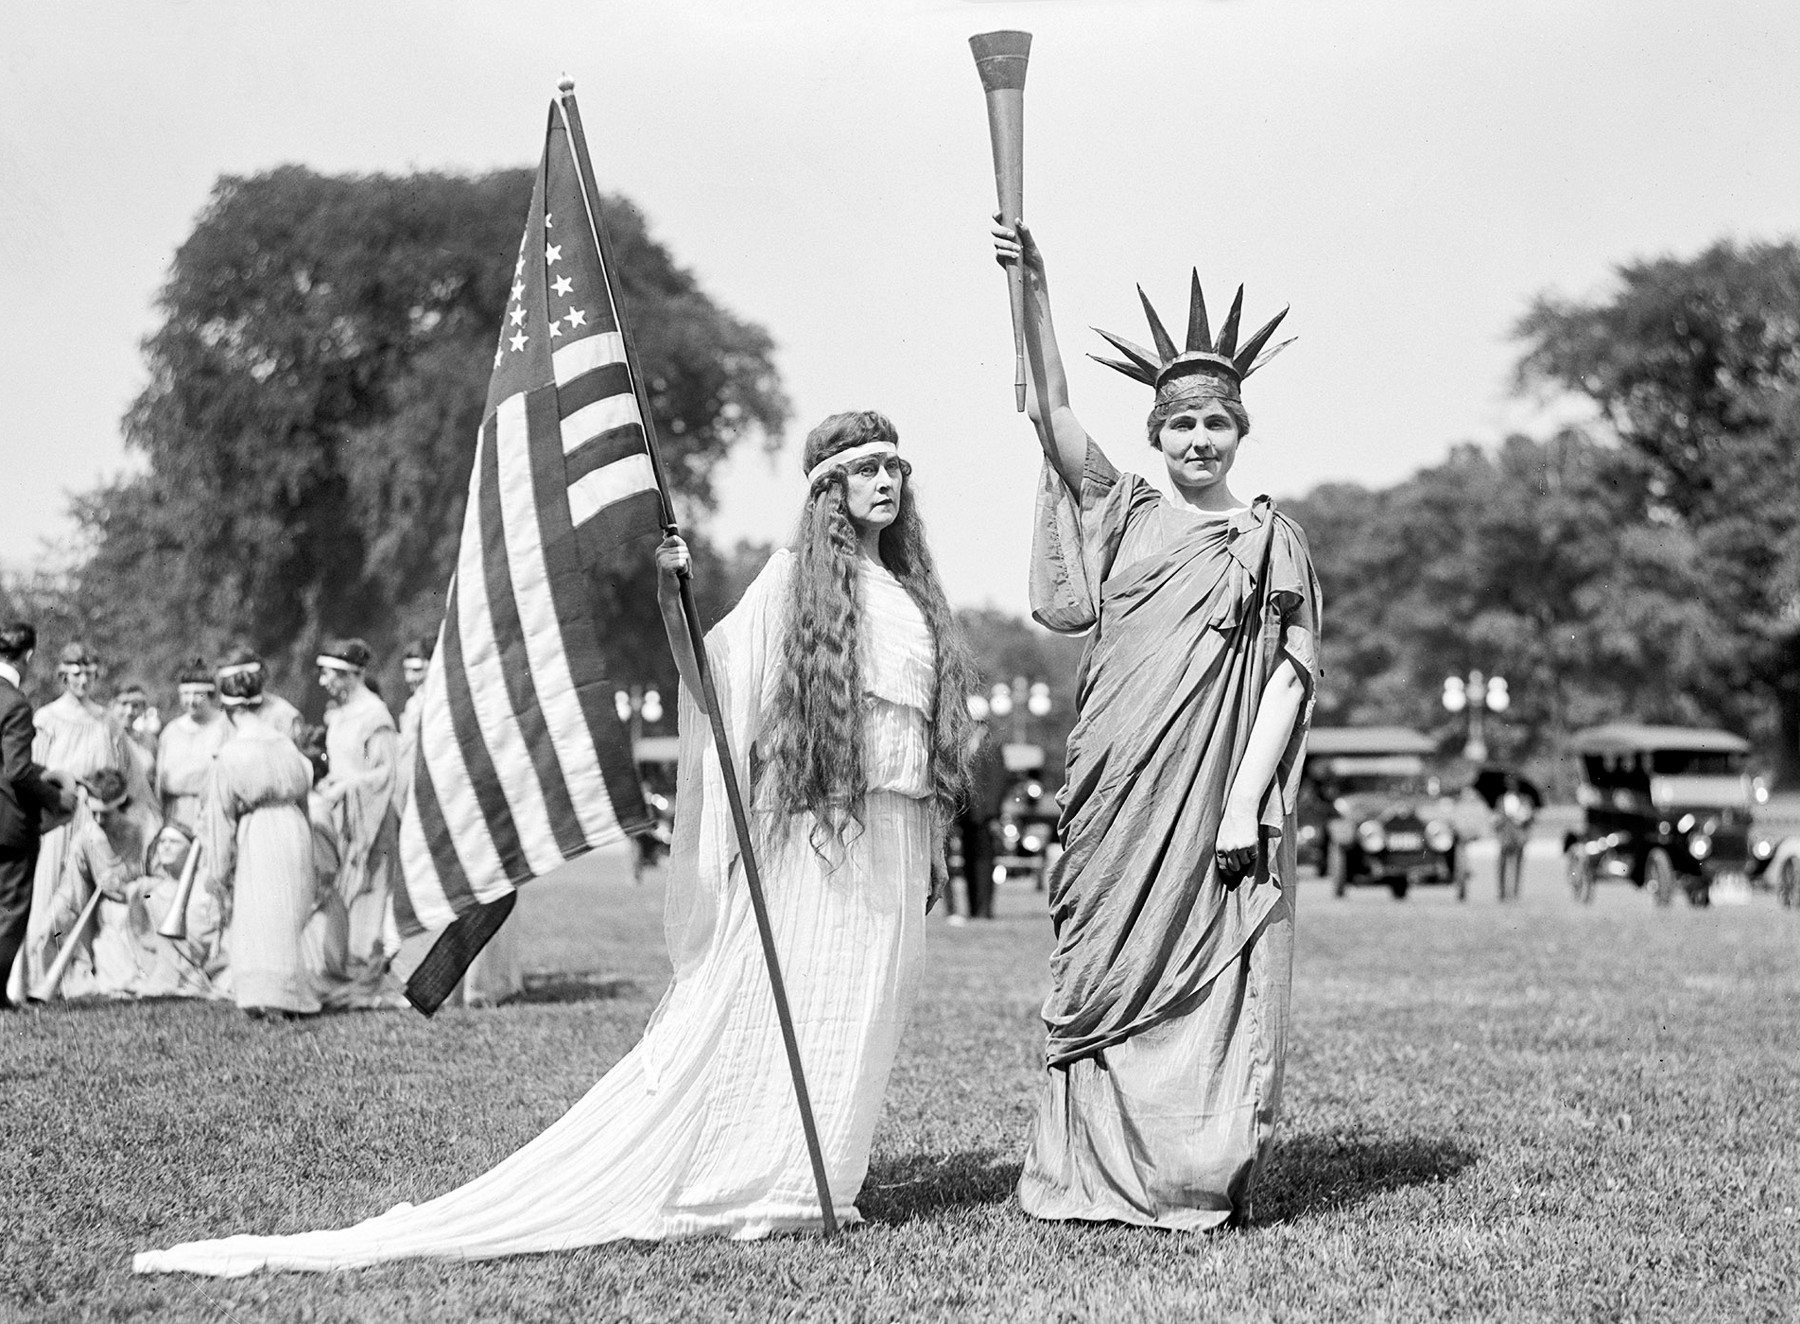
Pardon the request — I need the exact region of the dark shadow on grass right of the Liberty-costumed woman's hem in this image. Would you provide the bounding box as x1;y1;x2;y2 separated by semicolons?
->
1256;1133;1481;1223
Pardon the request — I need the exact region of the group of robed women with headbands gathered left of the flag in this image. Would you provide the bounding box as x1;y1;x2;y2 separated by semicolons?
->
7;639;520;1018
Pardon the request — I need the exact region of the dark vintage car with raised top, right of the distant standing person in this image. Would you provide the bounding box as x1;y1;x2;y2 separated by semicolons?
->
1562;721;1757;905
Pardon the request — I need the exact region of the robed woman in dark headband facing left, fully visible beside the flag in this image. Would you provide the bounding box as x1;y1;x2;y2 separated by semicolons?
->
319;639;400;979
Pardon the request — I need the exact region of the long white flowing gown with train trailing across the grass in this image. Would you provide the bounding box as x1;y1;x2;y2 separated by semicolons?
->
133;552;934;1275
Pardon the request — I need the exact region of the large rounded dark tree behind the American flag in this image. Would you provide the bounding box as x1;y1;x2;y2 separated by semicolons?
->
76;166;787;708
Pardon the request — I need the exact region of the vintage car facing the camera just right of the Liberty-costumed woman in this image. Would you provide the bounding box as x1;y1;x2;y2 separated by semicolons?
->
1296;727;1469;899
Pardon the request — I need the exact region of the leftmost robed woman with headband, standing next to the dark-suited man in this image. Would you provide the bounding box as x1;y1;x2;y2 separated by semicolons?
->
7;640;130;1004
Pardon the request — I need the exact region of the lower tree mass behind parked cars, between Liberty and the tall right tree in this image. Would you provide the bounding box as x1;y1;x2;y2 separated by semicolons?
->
1287;432;1717;780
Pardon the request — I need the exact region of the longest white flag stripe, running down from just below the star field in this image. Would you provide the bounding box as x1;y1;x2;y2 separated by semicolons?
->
495;394;623;845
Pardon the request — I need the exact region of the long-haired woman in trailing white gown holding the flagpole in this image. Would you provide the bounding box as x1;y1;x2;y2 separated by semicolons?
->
135;412;974;1275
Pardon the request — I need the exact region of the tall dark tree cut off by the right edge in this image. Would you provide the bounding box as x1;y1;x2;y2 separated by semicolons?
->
1517;241;1800;774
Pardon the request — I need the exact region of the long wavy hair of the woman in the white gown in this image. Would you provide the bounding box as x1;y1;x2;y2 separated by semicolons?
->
761;410;976;854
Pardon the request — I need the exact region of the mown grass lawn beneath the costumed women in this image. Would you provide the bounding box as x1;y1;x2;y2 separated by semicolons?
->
0;841;1800;1320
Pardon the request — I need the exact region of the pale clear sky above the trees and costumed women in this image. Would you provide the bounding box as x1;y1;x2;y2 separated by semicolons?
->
0;0;1800;612
